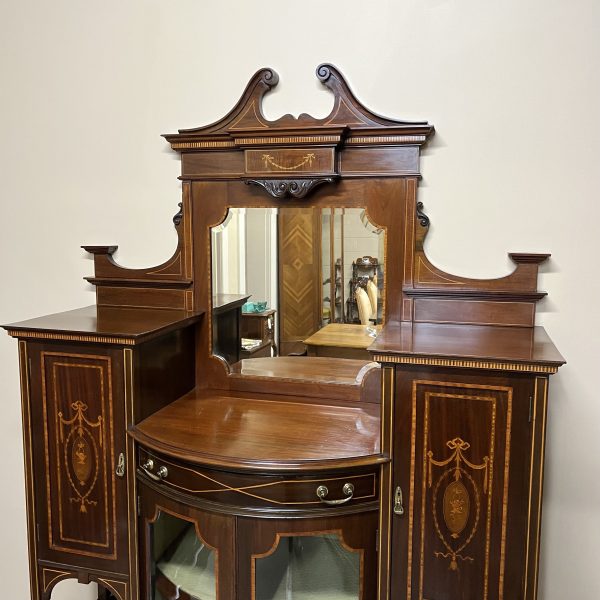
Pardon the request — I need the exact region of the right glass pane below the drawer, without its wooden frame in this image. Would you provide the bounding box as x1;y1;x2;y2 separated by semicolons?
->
255;534;361;600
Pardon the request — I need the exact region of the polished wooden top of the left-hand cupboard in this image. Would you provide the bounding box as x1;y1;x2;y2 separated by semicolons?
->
2;306;203;344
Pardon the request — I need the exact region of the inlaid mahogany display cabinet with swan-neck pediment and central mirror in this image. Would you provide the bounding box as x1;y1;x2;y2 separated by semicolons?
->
5;64;564;600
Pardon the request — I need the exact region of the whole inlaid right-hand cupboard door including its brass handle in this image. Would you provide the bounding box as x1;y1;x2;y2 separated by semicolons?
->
390;371;533;600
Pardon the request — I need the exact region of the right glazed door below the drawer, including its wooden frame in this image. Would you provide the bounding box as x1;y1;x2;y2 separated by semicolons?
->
237;511;377;600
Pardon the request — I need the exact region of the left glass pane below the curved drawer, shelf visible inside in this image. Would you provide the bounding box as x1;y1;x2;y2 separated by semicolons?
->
151;513;216;600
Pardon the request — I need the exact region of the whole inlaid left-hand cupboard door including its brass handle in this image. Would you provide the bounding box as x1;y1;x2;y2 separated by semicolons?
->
30;344;129;575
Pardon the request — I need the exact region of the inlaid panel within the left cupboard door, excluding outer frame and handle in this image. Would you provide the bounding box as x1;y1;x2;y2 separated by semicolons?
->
41;352;117;559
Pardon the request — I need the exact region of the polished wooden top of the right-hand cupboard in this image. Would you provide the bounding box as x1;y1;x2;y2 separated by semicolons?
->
369;323;565;370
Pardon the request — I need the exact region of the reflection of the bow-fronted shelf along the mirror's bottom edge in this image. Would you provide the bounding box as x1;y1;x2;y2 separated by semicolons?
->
231;356;379;386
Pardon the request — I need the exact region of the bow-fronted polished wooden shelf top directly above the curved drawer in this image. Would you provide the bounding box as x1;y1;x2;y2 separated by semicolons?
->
131;390;386;472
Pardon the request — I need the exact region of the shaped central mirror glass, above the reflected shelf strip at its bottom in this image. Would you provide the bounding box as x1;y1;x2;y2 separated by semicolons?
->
211;207;385;364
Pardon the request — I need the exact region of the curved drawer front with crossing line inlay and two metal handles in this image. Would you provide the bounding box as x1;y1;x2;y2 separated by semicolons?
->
138;448;379;510
